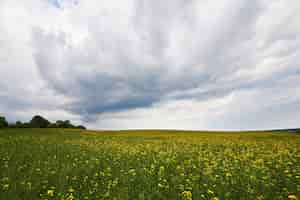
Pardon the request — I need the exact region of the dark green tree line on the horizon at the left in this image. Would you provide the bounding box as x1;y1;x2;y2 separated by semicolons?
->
0;115;86;129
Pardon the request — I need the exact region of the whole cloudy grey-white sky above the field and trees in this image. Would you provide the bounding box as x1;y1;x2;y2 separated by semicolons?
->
0;0;300;130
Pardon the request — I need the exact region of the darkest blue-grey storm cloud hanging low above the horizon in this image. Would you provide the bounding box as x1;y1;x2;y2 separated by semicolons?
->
34;25;213;118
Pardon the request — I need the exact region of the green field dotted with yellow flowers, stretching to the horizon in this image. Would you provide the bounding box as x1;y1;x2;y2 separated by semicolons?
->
0;129;300;200
